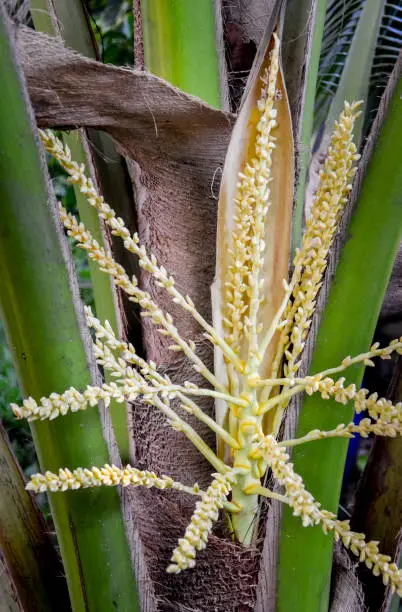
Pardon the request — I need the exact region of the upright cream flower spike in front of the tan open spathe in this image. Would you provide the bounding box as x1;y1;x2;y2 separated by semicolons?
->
223;38;279;352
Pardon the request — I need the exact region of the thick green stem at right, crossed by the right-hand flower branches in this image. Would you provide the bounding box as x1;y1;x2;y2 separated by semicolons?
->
278;59;402;612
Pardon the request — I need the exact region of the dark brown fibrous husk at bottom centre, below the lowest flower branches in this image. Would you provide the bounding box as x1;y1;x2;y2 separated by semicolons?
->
127;489;259;612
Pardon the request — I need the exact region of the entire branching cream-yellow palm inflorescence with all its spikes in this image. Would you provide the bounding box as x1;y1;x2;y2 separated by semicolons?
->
12;36;402;593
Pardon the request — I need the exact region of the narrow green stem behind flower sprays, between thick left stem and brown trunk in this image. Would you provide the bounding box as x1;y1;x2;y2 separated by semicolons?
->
31;0;131;463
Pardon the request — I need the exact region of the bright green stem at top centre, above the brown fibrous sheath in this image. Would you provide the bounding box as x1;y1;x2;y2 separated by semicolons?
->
141;0;221;108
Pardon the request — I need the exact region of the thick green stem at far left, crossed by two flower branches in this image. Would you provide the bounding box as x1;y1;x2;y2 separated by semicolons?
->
0;5;138;612
